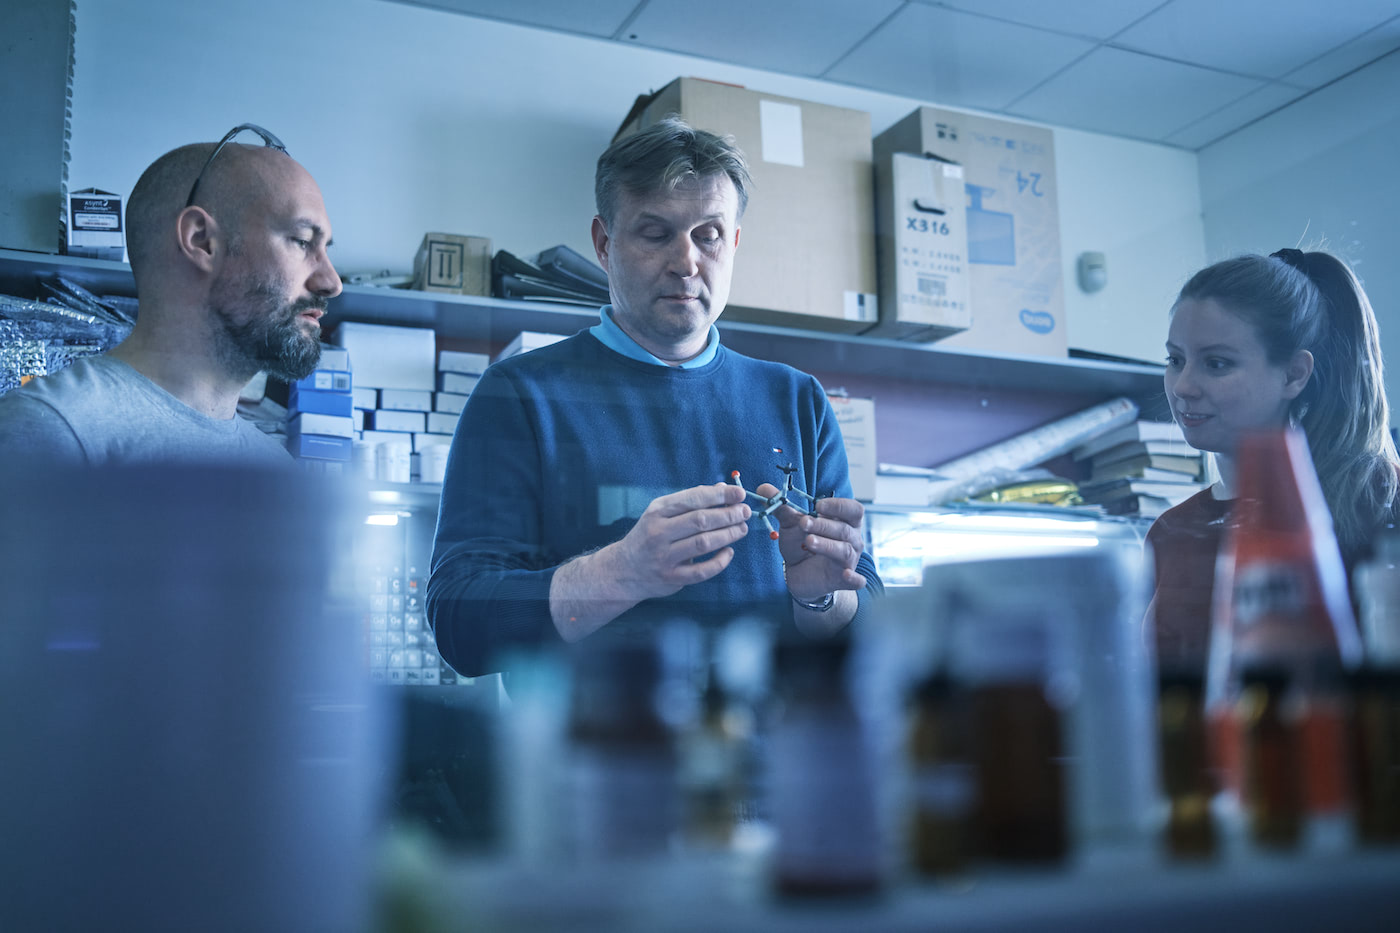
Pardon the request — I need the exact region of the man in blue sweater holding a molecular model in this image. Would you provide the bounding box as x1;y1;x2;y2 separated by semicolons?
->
427;119;882;675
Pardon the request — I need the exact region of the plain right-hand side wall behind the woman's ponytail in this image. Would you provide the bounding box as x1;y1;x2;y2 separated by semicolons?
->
1200;47;1400;420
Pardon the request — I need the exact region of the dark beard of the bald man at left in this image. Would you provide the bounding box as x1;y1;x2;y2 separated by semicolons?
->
210;267;326;382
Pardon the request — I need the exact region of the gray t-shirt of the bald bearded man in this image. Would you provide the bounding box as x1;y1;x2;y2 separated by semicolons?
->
0;356;291;467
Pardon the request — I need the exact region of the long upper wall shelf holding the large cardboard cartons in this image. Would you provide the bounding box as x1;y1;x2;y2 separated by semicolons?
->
0;249;1162;402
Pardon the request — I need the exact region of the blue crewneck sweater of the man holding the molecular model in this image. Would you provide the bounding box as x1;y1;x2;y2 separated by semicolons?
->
427;332;881;675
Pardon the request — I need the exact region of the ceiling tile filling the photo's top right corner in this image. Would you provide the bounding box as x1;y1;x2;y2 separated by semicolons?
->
1113;0;1400;78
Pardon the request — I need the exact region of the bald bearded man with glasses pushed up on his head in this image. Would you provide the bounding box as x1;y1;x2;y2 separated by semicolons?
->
0;126;340;467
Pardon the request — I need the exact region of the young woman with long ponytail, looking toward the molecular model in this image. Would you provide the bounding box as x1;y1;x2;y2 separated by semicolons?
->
1148;249;1400;667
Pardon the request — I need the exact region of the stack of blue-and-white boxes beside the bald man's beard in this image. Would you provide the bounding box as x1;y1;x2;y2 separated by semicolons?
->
287;346;356;474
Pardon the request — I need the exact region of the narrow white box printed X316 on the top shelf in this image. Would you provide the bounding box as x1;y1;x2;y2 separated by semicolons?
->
867;153;972;340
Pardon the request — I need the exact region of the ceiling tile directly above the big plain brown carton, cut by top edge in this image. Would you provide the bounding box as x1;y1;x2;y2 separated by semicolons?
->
622;0;903;76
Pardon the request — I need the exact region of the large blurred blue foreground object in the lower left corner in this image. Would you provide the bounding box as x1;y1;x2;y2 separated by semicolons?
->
0;467;384;932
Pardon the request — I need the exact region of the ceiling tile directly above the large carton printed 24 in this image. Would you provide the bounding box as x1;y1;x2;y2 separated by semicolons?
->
823;3;1093;111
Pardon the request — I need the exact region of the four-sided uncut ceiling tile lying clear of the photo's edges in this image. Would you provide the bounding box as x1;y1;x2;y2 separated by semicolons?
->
1009;48;1264;140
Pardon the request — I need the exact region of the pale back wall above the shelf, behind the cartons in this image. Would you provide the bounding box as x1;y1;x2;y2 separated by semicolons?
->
70;0;1204;359
